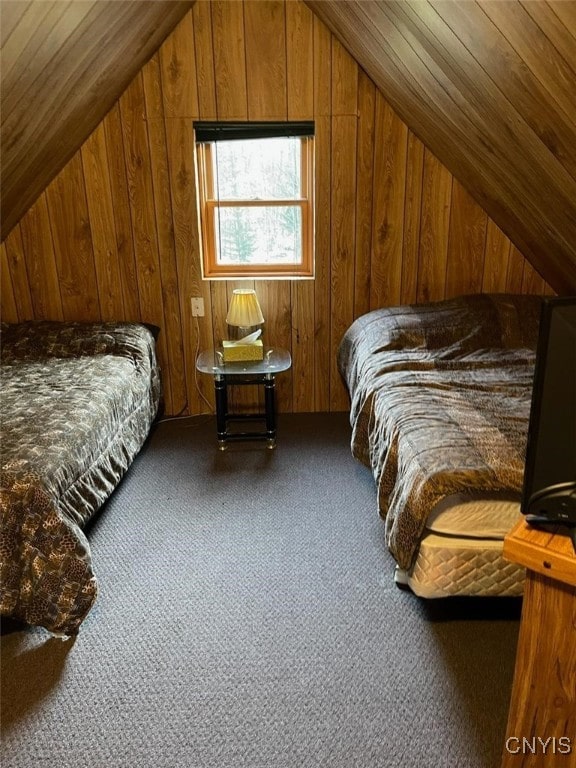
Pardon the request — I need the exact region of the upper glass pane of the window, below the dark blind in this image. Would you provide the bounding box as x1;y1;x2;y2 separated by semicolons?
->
213;137;301;200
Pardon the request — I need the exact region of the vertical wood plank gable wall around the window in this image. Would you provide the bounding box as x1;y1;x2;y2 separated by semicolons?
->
0;0;550;414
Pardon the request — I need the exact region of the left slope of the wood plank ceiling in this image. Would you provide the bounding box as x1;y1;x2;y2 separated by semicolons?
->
0;0;193;240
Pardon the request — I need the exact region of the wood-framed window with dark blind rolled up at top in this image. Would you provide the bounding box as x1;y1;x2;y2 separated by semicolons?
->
194;122;314;278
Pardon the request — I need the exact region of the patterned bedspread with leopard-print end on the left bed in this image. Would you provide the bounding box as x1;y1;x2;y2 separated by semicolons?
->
0;322;160;635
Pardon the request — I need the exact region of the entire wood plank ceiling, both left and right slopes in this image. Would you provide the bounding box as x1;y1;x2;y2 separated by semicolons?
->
0;0;576;293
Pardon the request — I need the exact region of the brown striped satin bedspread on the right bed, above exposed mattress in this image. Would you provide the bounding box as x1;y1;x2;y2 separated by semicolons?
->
338;294;541;569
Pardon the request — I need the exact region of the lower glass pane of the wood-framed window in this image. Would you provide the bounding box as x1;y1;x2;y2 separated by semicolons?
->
214;205;302;265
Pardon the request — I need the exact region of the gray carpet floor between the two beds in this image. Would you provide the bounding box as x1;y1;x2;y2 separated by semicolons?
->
0;414;520;768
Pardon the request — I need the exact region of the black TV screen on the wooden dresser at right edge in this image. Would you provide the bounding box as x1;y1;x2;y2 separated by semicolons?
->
521;297;576;523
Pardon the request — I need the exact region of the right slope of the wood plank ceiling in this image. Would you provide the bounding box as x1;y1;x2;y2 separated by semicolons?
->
306;0;576;293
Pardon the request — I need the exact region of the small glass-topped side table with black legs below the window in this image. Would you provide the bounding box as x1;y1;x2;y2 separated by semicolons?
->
196;348;292;451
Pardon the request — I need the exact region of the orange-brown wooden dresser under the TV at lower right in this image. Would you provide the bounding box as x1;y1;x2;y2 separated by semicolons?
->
502;520;576;768
